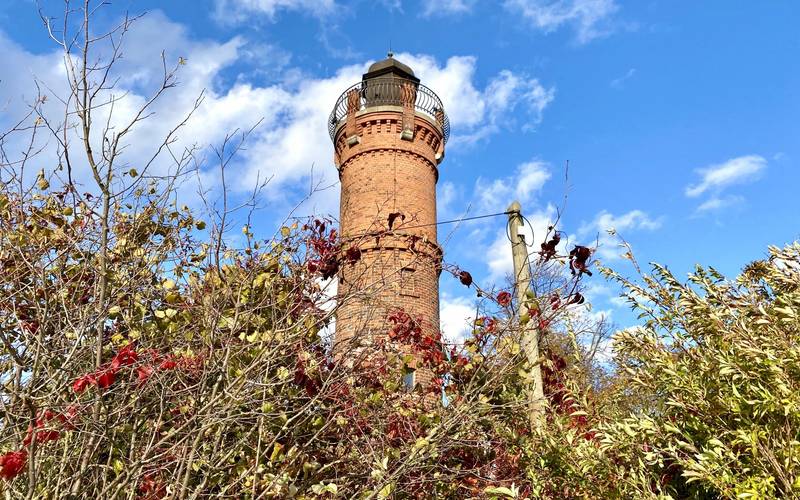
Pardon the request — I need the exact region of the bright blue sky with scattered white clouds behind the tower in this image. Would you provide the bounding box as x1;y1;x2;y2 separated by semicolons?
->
0;0;800;344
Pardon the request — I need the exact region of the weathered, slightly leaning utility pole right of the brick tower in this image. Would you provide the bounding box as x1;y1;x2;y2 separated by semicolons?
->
506;201;545;427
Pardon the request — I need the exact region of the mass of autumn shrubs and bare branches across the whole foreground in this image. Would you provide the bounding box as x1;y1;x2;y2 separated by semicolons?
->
0;3;800;499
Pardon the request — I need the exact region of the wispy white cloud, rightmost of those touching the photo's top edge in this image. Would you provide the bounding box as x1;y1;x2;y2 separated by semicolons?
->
504;0;619;43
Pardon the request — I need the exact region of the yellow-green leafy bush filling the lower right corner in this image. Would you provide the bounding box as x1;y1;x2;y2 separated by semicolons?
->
600;243;800;498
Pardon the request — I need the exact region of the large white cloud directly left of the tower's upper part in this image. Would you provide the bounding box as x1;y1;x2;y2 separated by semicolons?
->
105;13;356;213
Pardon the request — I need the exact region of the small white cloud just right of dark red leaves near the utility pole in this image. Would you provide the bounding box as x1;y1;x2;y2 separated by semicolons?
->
578;210;662;261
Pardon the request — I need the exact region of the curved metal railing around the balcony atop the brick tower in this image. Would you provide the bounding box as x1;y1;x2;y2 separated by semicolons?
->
328;78;450;142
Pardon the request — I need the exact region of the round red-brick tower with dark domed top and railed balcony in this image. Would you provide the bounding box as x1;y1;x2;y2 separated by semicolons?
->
329;53;450;385
